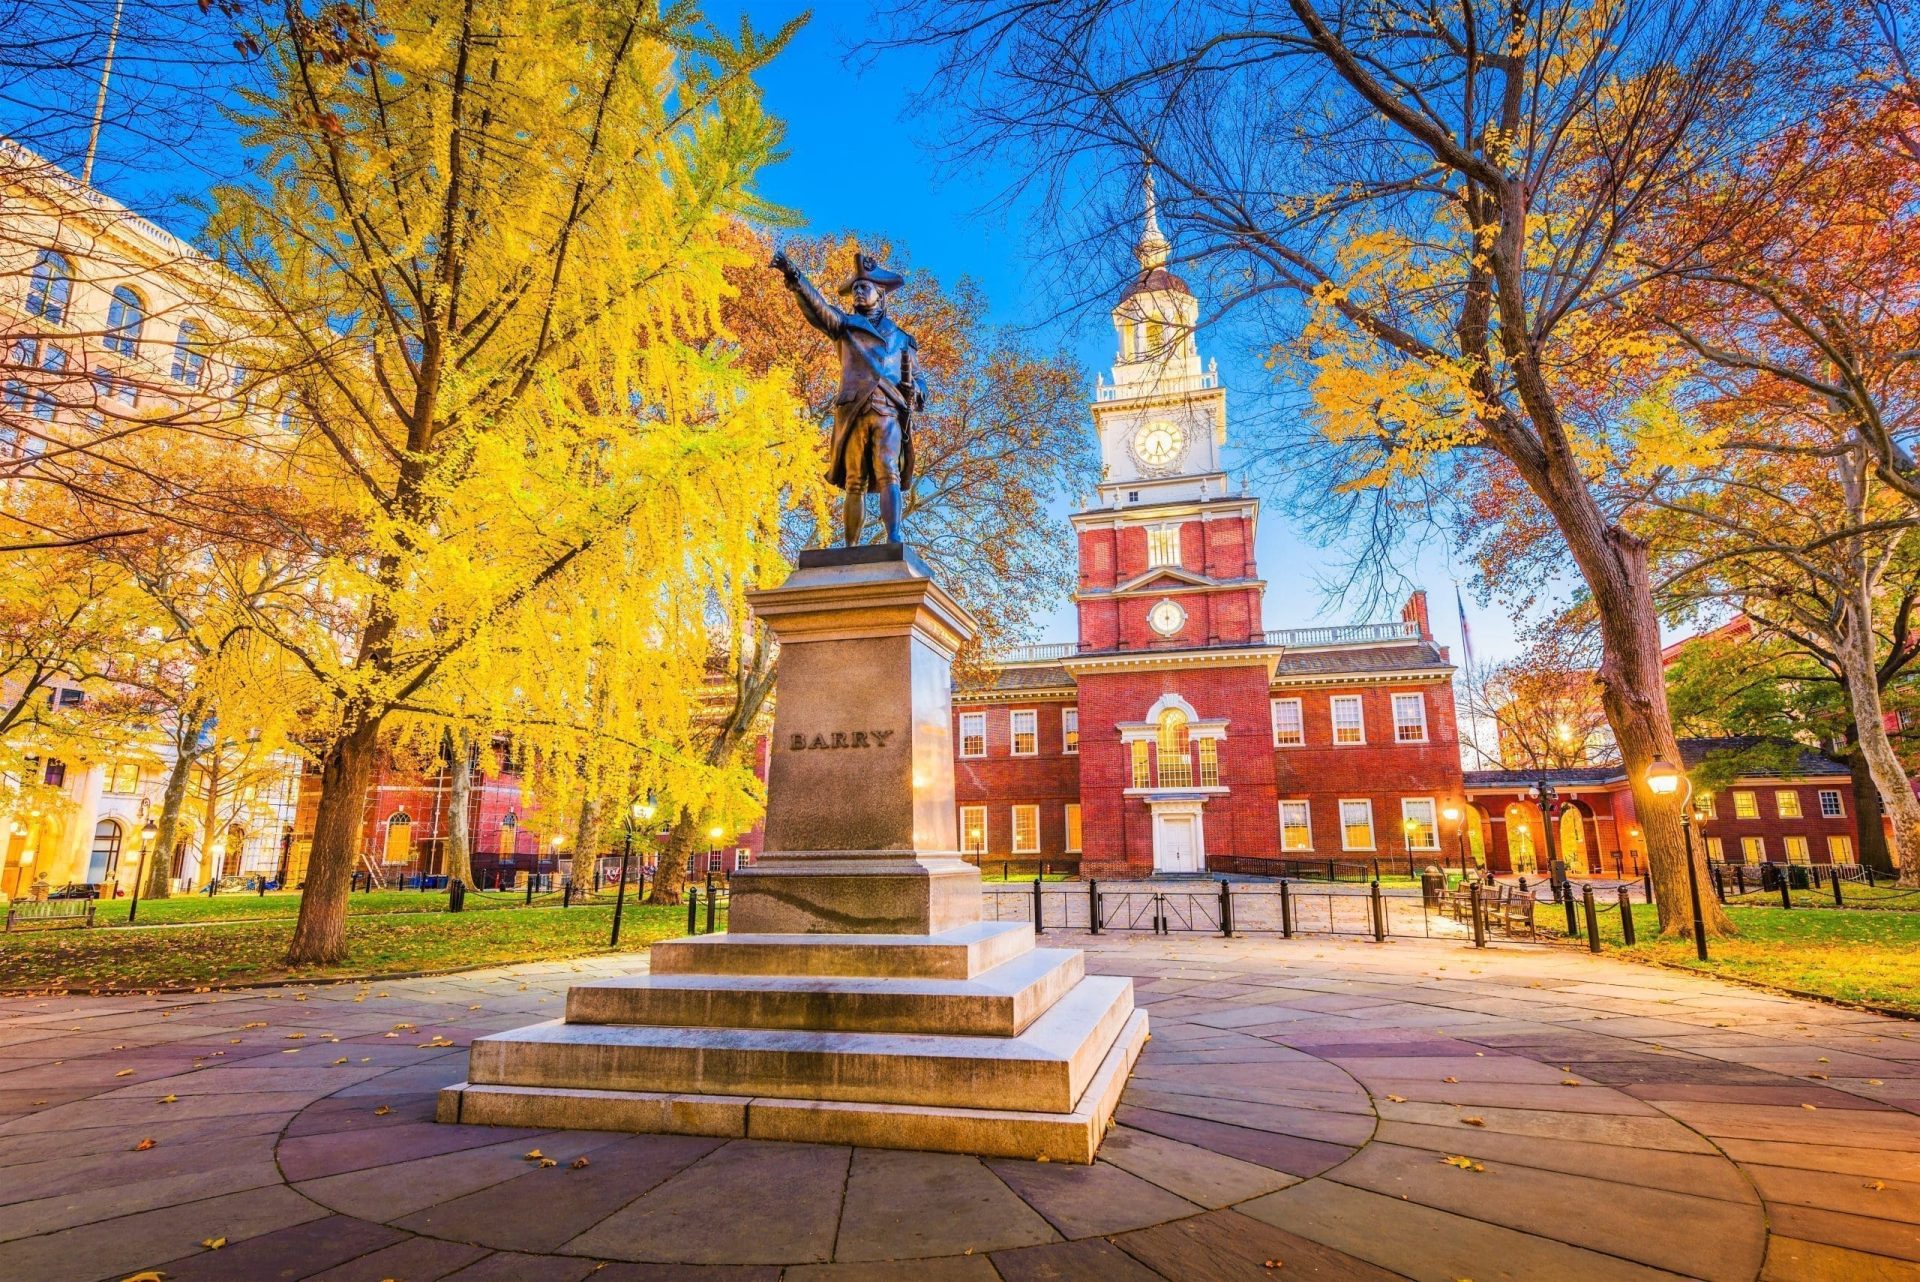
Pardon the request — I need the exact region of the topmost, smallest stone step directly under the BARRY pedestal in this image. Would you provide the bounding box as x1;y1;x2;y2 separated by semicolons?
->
651;921;1033;979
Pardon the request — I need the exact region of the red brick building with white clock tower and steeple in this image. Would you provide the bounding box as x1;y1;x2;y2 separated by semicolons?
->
954;188;1463;877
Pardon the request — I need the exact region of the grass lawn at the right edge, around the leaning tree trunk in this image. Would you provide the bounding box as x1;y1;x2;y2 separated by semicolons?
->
1540;898;1920;1015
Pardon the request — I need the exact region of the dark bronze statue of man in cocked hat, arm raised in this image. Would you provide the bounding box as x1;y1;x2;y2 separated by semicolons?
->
772;249;927;547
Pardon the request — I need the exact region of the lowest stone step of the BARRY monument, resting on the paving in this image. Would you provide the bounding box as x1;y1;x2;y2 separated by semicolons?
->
438;1011;1146;1163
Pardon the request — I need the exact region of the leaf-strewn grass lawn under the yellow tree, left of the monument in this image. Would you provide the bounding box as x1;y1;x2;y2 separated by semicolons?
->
0;892;726;990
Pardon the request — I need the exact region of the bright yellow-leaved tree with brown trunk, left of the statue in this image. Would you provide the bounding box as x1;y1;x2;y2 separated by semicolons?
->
209;0;818;965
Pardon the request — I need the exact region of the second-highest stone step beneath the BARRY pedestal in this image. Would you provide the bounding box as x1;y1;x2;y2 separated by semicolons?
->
566;948;1087;1036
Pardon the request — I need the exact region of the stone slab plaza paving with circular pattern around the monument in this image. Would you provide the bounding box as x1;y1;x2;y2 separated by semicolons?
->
0;937;1920;1282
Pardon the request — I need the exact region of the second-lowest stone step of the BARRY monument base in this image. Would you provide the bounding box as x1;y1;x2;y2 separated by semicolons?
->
467;975;1133;1113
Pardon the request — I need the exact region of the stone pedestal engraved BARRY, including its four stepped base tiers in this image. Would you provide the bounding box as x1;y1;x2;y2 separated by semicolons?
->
440;545;1146;1163
